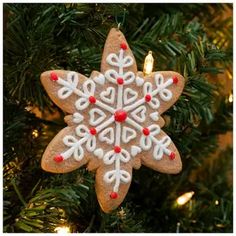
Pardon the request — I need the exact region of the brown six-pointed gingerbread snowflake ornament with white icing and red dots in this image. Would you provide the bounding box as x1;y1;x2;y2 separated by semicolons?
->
41;29;184;212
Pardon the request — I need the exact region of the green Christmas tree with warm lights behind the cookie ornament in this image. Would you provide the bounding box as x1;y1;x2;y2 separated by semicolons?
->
3;3;233;233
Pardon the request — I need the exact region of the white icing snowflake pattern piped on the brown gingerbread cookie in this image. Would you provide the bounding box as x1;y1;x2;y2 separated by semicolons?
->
53;42;177;192
